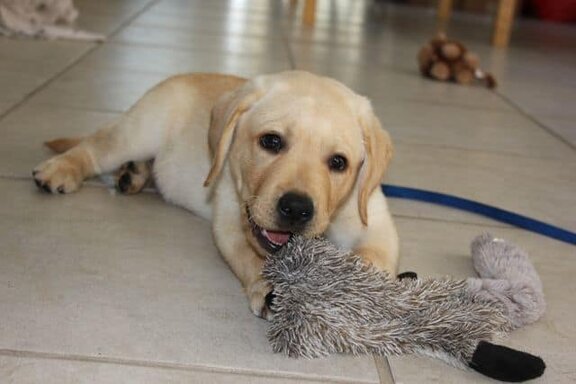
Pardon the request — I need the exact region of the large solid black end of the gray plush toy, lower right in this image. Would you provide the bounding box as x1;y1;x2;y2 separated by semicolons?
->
468;341;546;383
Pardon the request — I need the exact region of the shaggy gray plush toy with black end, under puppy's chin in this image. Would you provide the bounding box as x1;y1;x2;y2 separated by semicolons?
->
263;234;545;382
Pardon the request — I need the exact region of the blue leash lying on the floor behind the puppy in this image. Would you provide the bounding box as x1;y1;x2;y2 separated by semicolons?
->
382;184;576;245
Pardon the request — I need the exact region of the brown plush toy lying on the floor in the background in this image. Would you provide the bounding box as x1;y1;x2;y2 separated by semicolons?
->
418;33;496;88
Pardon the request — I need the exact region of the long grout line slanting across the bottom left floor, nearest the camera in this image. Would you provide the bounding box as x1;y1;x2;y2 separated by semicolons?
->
0;349;374;384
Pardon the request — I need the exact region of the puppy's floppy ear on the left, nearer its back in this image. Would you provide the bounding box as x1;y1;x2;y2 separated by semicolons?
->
204;82;263;187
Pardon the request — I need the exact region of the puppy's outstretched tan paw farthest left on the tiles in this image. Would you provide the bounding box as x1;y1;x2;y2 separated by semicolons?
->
32;156;84;193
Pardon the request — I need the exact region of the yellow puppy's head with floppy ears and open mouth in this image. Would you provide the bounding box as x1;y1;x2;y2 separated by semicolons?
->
206;71;392;254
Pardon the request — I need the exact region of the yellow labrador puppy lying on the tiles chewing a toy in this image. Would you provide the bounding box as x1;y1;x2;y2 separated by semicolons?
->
33;71;398;317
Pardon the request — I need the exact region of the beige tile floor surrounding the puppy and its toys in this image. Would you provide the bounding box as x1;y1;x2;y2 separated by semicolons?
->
0;0;576;384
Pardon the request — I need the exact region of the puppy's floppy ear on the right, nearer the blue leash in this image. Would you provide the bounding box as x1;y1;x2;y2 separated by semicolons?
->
358;99;393;225
